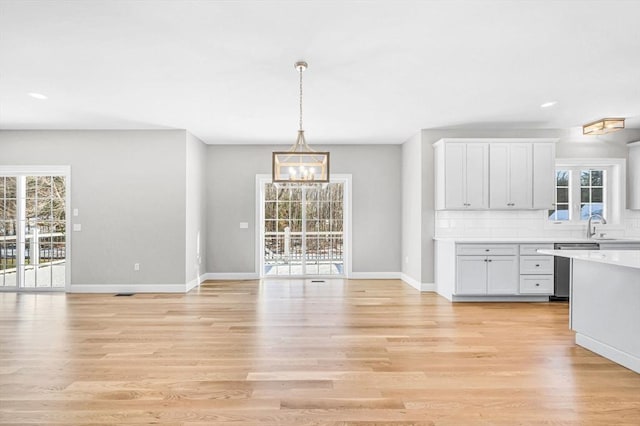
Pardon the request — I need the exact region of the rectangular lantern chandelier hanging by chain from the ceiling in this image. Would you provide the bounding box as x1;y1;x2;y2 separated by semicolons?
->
272;61;329;184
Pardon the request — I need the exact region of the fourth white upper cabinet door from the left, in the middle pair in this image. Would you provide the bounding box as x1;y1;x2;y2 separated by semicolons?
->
508;143;533;209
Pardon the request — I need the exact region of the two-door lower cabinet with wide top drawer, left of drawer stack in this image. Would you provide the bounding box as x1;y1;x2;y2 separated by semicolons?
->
456;244;518;296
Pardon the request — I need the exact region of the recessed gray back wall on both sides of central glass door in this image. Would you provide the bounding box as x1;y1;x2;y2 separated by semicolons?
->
206;145;402;273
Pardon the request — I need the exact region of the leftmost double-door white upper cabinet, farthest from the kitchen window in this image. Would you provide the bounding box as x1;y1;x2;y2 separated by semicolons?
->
434;142;489;210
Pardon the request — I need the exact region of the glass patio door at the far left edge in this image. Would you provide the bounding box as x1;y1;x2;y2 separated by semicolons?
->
0;168;68;291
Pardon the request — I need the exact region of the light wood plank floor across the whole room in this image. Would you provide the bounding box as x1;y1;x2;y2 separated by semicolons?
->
0;280;640;426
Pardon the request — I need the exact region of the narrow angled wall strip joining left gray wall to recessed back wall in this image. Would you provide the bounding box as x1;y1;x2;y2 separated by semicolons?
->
185;132;207;283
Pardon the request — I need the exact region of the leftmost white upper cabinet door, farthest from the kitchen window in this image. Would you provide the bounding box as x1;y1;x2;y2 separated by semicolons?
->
444;143;467;209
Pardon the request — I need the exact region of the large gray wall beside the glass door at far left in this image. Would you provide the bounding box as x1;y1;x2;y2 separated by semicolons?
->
0;130;186;285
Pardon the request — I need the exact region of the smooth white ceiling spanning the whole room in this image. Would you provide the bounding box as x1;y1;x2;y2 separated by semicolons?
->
0;0;640;145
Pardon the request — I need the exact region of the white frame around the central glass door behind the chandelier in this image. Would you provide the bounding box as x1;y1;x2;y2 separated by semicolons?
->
255;174;352;279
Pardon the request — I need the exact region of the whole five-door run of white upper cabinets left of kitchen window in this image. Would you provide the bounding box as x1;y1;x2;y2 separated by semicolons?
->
433;138;555;210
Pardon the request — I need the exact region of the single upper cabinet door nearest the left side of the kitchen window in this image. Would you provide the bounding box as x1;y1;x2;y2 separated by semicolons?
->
533;143;556;210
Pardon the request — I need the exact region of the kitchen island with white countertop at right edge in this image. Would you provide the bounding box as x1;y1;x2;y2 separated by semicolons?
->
538;250;640;373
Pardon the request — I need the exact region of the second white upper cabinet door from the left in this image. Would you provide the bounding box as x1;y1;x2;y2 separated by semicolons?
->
465;143;489;209
